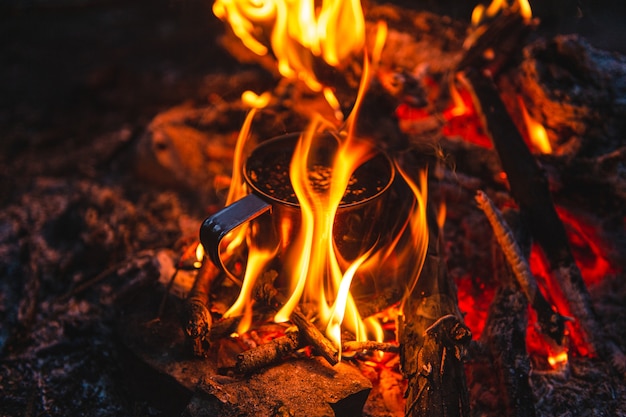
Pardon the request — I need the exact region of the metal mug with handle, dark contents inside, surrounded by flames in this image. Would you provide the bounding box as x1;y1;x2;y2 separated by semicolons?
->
200;133;395;270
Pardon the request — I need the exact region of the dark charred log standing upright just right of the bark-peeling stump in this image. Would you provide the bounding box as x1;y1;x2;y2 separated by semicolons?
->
482;211;536;417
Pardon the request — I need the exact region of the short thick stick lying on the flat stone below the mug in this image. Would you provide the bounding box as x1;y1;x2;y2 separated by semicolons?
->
235;331;300;374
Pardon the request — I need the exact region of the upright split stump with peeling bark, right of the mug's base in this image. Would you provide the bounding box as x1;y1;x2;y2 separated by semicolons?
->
398;211;471;417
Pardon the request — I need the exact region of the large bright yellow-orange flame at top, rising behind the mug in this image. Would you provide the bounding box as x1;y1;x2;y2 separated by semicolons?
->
213;0;365;91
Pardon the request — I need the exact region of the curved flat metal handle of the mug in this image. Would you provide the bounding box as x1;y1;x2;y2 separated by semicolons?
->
200;194;272;271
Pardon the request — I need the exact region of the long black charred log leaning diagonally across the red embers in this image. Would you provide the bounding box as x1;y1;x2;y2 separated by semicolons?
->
466;71;624;364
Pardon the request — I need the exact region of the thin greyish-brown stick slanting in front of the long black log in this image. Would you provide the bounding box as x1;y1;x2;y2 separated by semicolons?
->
476;191;567;345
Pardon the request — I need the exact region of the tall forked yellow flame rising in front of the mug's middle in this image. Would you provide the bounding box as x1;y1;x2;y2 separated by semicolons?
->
275;125;372;348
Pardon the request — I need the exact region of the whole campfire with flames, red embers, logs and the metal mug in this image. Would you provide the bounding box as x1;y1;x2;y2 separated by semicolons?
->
2;0;626;417
